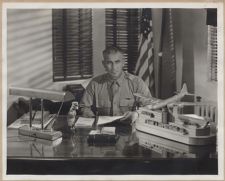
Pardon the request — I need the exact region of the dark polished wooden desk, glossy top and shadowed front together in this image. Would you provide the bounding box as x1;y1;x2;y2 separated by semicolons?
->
7;116;218;175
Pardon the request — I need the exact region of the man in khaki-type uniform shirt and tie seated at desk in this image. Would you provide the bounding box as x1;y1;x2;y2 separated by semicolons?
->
80;47;151;123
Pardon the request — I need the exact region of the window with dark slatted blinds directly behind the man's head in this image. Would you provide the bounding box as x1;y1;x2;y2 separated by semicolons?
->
105;9;140;73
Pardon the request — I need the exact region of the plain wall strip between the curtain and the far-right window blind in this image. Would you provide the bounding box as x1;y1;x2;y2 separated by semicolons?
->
193;10;217;101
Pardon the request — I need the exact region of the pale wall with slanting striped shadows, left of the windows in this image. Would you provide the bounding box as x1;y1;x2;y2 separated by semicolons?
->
7;9;53;106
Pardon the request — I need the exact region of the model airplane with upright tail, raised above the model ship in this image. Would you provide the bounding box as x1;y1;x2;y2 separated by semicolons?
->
134;84;193;110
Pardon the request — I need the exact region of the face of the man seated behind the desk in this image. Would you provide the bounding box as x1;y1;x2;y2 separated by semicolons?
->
102;52;124;79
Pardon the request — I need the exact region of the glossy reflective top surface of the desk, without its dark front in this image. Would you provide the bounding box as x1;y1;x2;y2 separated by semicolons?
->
7;116;217;159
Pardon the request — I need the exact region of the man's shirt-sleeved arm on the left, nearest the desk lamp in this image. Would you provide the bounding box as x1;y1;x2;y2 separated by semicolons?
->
80;81;95;117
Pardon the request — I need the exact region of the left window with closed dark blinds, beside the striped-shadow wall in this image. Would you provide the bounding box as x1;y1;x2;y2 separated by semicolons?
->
52;9;93;81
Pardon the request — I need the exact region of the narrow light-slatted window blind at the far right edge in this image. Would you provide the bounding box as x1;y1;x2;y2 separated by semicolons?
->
208;25;217;81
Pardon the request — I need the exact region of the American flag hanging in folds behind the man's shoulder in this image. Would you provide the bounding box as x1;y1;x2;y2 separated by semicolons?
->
135;9;155;96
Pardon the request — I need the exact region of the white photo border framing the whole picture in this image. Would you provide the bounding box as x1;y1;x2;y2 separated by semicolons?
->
2;2;224;180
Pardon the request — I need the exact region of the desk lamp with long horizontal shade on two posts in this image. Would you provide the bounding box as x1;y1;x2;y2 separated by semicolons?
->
9;87;75;141
